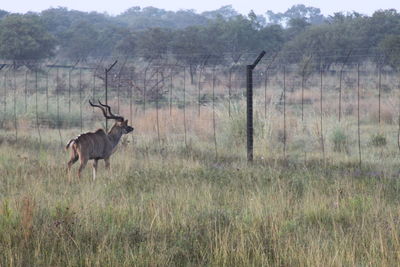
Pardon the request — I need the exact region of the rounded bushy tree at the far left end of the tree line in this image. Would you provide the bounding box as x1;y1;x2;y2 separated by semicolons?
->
0;14;55;60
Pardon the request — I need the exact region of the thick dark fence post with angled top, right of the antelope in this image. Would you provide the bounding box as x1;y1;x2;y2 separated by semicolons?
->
246;51;265;162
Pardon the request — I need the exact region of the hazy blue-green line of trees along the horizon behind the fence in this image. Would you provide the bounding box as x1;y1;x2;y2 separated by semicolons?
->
0;4;400;69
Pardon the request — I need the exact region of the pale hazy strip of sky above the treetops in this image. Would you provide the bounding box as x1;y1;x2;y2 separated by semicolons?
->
0;0;400;15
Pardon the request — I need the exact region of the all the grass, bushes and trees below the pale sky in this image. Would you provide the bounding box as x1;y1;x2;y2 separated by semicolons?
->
0;2;400;266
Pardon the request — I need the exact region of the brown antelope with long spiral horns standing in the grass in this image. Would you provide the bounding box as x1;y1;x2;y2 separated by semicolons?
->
66;100;133;180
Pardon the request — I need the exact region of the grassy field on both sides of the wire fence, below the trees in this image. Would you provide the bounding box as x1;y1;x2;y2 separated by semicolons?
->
0;65;400;266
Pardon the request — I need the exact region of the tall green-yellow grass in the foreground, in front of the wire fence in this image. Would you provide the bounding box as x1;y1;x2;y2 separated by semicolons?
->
0;130;400;266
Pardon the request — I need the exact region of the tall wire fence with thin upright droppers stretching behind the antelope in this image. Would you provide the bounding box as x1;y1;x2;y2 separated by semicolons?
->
0;55;400;164
